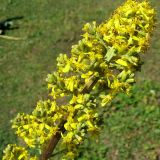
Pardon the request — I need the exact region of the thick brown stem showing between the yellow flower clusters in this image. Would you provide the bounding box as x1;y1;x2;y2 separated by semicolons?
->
40;76;98;160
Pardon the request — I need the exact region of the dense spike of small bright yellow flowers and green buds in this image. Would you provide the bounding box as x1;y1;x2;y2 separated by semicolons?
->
3;0;155;160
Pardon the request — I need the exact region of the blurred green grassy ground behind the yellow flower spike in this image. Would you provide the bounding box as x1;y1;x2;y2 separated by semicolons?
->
0;0;160;160
